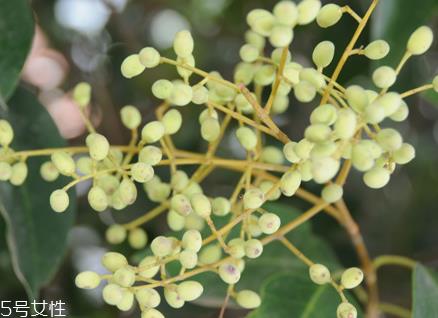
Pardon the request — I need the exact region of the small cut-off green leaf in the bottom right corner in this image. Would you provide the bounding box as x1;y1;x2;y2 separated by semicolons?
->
412;264;438;318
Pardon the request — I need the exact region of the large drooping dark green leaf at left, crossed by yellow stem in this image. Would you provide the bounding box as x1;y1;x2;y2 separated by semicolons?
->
0;90;76;299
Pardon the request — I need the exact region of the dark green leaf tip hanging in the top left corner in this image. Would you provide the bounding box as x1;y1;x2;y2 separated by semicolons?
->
0;0;34;101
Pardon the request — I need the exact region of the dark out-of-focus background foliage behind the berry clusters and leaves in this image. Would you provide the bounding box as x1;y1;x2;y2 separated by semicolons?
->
0;0;438;318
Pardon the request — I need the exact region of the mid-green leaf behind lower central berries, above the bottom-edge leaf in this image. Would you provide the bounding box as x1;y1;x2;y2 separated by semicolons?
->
172;203;339;307
